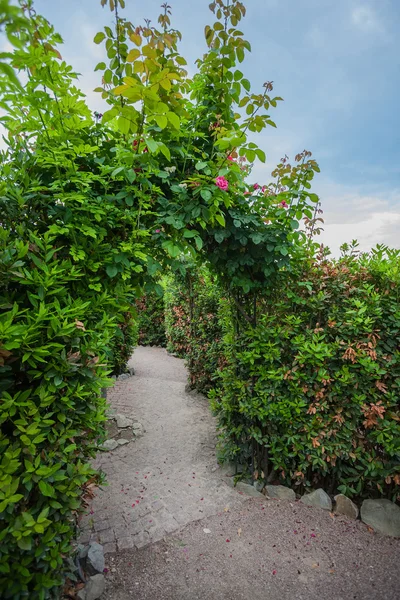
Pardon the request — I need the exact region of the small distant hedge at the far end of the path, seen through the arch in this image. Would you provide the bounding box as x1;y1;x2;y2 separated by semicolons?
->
136;292;167;348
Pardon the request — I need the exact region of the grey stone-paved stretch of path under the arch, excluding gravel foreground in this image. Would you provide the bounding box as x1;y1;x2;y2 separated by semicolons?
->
82;348;245;554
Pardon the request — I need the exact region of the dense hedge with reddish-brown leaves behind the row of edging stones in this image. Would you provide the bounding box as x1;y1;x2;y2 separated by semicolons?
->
213;250;400;499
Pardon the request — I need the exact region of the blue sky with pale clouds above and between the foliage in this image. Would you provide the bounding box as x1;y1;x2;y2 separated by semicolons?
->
30;0;400;252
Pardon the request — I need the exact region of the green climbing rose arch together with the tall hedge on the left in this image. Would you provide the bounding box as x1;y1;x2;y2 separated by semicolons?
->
0;0;318;600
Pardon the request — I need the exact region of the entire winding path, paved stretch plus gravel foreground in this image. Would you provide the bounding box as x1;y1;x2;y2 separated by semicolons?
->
82;348;400;600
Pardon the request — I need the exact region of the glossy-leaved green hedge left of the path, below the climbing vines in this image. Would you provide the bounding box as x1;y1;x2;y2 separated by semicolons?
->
0;229;111;600
